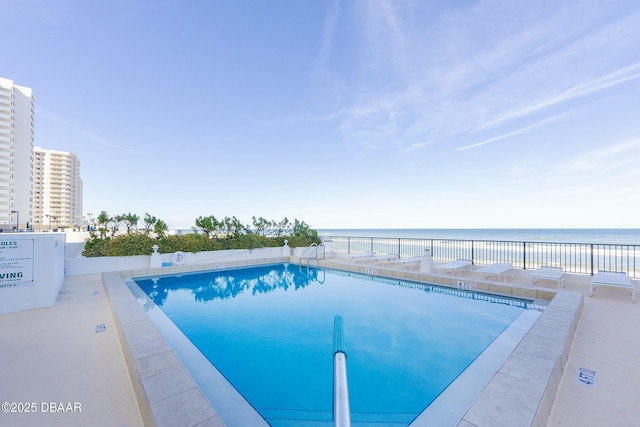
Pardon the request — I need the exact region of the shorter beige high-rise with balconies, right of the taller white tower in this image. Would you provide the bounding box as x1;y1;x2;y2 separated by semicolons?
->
33;147;82;230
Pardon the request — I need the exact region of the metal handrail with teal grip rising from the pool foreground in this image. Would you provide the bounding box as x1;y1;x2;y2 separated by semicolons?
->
333;316;351;427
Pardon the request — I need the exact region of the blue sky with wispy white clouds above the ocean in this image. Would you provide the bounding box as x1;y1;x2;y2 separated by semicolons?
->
0;0;640;229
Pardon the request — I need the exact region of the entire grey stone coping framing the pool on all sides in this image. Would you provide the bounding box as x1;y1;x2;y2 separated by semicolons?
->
102;257;584;427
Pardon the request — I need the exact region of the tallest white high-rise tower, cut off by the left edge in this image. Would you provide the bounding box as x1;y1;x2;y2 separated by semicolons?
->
0;77;35;231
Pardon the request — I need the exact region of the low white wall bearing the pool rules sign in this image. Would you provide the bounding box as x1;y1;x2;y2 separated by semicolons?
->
0;233;65;314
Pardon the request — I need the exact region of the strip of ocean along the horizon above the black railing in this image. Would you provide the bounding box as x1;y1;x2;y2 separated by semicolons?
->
317;228;640;245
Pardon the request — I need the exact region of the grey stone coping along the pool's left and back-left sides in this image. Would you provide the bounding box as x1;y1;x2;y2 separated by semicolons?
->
102;257;289;427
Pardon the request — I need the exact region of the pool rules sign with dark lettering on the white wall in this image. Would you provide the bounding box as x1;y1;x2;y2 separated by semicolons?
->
0;239;33;288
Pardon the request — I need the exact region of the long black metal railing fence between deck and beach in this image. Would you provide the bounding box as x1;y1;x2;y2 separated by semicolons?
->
330;236;640;279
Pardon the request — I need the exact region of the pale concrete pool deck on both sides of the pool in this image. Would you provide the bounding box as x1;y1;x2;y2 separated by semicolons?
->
0;261;640;427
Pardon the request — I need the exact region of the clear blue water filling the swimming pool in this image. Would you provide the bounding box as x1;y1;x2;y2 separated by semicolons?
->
135;264;540;427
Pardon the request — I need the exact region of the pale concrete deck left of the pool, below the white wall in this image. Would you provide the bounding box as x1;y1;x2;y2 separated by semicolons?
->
0;275;143;427
